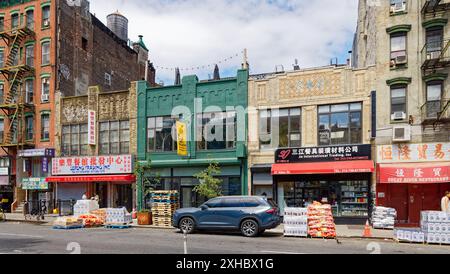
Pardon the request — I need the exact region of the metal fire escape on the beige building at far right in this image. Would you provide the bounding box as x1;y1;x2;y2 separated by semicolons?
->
421;0;450;129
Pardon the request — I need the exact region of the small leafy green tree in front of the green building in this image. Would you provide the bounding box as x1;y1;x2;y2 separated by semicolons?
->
194;162;222;199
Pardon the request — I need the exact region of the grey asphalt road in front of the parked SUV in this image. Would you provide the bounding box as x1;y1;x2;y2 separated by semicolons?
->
0;222;450;255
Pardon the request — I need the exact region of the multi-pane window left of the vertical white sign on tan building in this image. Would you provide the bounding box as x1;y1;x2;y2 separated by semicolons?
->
61;124;88;156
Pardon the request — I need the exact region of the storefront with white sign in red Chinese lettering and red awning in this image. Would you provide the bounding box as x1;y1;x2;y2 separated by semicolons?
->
46;155;136;212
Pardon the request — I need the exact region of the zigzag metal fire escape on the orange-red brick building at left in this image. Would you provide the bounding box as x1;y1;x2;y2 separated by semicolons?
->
0;16;34;156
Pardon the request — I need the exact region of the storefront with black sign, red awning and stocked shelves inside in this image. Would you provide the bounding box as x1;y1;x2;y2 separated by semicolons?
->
272;145;374;224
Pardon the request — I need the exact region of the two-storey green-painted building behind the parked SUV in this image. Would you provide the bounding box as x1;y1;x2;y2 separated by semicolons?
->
137;70;248;209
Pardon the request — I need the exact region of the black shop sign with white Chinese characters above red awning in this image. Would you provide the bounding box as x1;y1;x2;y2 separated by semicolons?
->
275;145;371;164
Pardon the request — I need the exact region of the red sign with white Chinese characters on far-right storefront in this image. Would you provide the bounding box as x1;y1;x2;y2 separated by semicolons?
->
378;163;450;184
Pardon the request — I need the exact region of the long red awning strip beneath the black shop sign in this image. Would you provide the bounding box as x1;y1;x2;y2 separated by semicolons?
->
272;160;375;175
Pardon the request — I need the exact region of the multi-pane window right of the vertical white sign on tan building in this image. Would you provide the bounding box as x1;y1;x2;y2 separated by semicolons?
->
99;121;130;155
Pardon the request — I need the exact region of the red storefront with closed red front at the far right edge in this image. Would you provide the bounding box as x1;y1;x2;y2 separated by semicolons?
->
377;143;450;227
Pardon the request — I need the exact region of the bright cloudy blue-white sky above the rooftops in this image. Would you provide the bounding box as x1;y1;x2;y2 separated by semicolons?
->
90;0;358;85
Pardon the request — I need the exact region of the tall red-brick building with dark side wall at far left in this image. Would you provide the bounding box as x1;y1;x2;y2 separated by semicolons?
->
0;0;155;211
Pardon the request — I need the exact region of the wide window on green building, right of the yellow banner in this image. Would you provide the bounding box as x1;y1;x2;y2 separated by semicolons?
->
197;111;237;150
